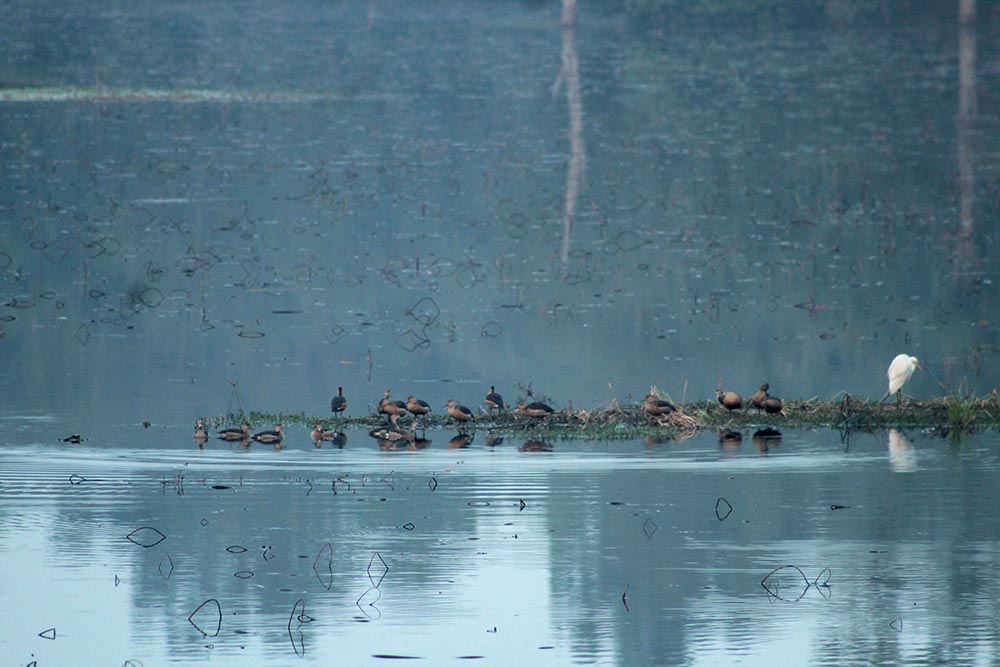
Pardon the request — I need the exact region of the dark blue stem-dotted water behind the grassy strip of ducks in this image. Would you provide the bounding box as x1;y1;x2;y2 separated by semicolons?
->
0;2;1000;422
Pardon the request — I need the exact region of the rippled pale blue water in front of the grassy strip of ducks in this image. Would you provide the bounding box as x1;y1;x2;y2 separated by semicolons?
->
0;426;1000;665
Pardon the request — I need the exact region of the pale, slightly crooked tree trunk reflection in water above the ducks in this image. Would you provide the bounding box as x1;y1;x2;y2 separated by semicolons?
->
557;0;586;277
